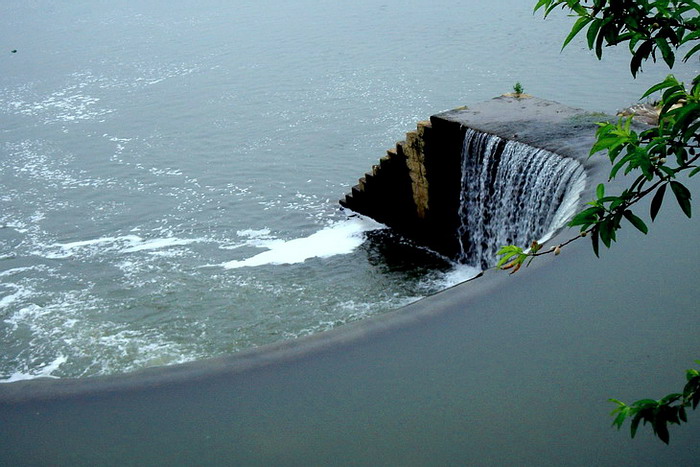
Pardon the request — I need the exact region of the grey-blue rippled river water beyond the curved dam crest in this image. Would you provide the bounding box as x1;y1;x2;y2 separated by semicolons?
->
0;0;697;381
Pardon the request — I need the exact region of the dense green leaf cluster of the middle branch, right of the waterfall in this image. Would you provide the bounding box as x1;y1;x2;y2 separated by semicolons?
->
569;79;700;256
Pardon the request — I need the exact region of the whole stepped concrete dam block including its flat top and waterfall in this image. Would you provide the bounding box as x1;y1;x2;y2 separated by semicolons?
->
340;96;603;269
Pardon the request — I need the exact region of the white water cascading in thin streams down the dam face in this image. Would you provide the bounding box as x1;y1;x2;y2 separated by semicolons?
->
458;128;586;269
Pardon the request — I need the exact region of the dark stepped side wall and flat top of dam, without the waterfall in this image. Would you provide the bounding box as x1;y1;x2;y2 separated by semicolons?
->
341;96;614;257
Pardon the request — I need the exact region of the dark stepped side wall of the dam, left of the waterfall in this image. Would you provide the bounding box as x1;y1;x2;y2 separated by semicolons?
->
340;116;464;260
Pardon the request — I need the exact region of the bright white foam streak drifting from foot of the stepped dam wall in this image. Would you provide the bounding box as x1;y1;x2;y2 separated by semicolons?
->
222;216;385;269
